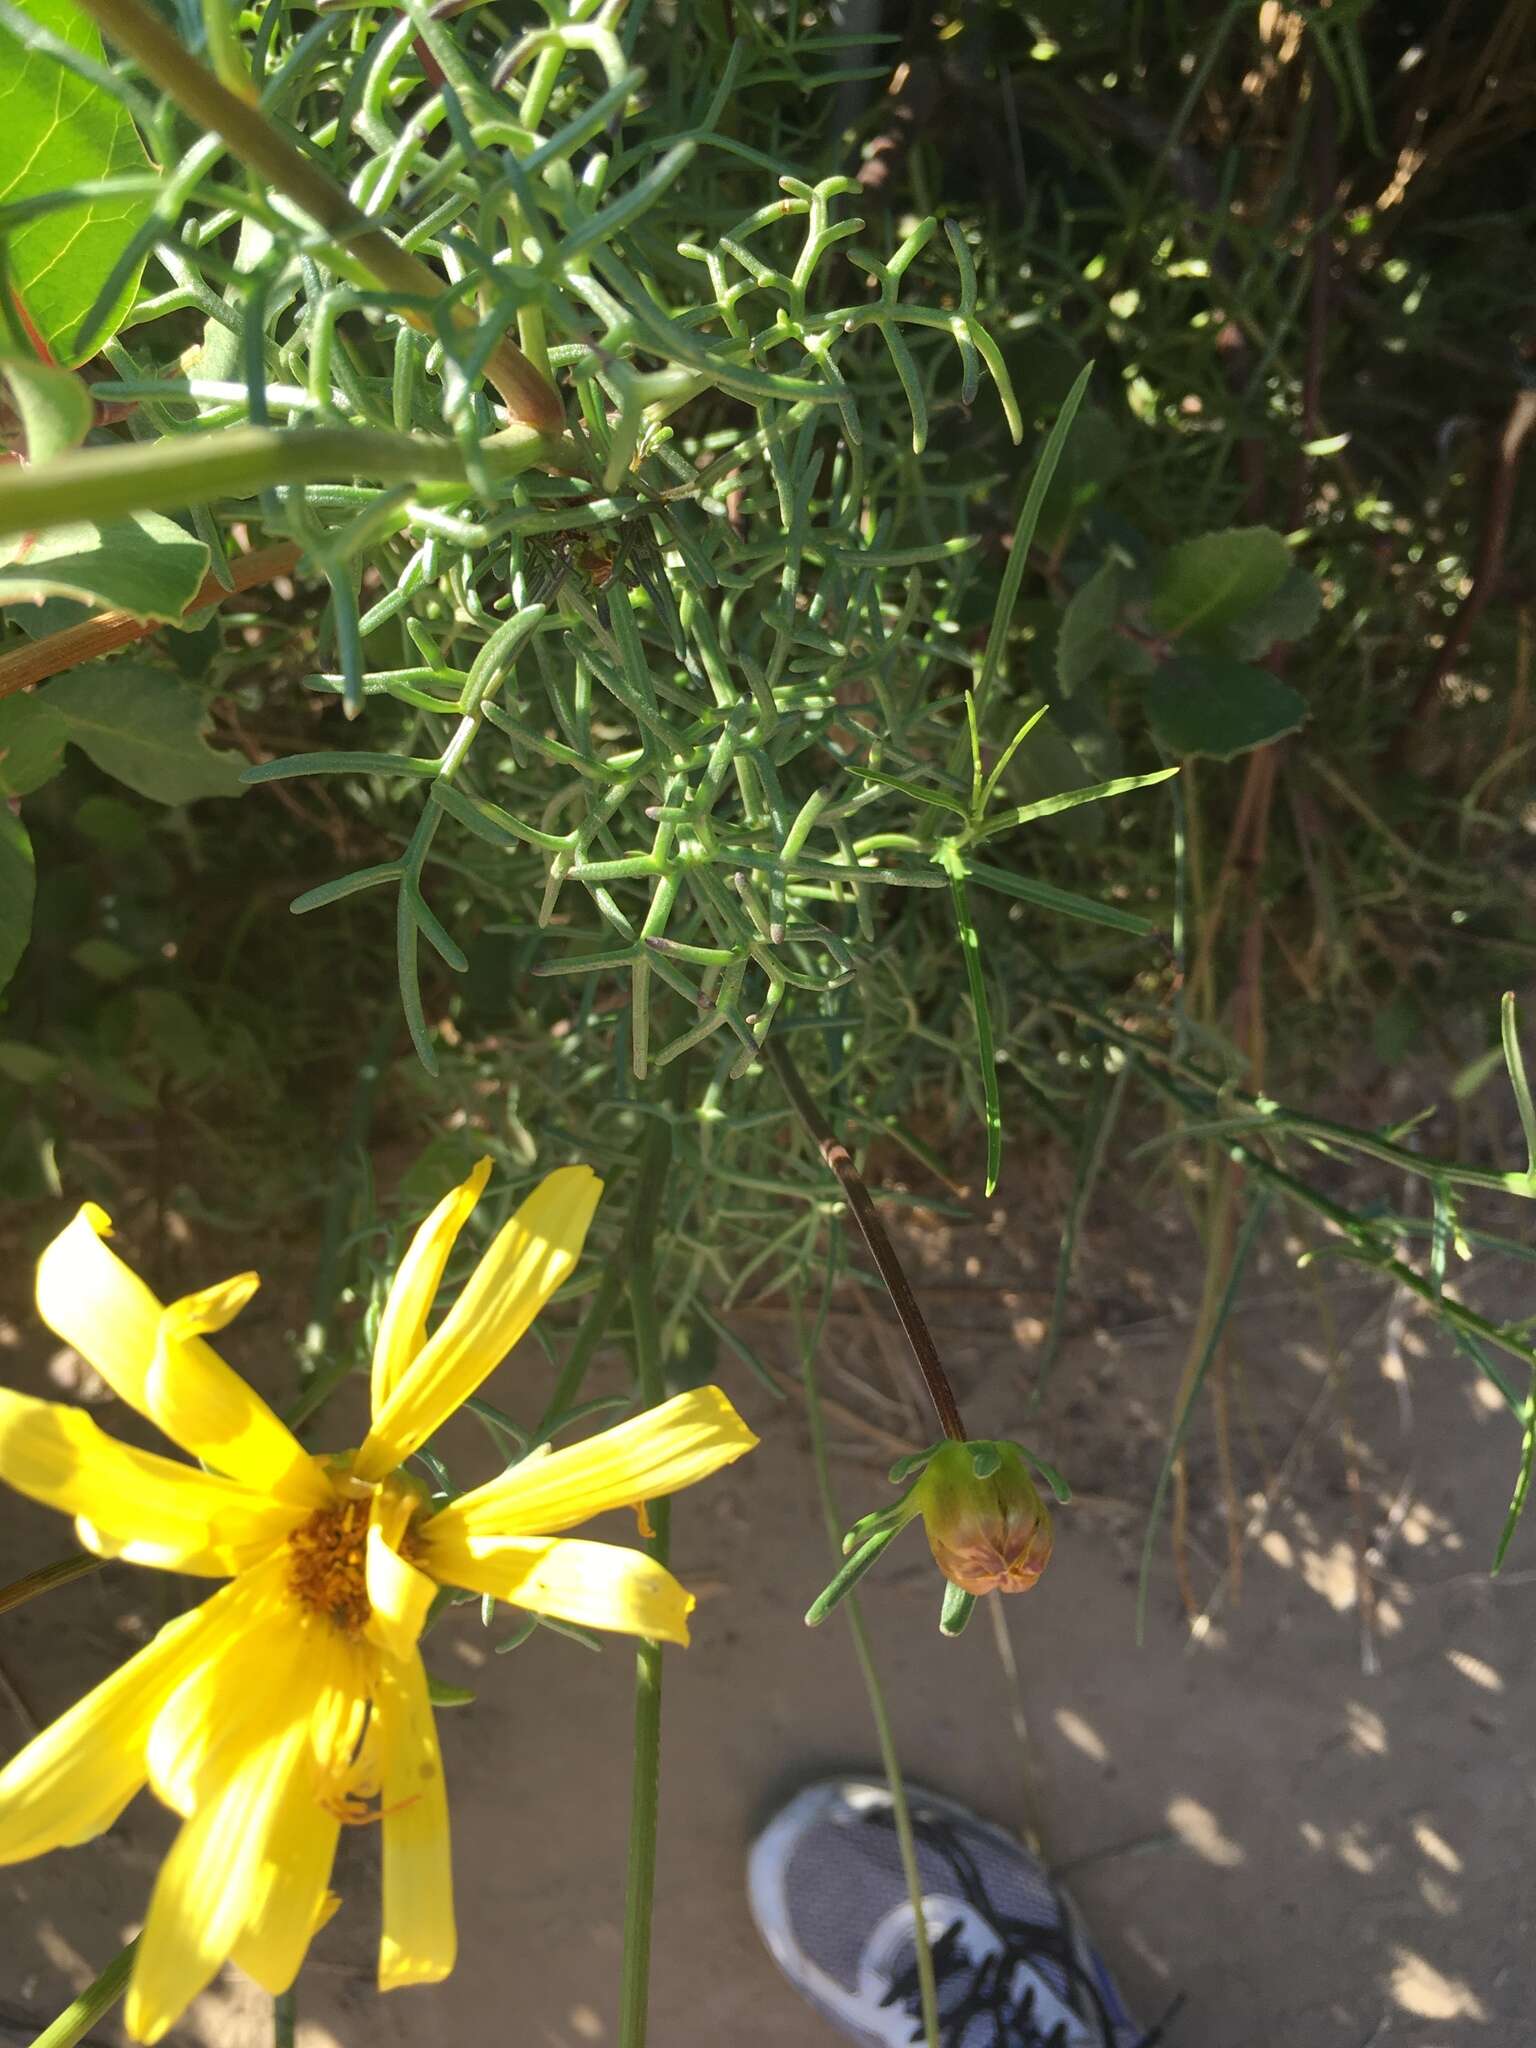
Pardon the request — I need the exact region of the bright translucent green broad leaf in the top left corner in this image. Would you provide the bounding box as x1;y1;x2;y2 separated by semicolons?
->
0;0;152;367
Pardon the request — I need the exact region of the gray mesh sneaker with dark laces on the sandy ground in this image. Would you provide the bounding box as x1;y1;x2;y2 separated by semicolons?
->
748;1778;1161;2048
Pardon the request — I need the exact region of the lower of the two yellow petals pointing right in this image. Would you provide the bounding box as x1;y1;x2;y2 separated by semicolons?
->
422;1540;694;1642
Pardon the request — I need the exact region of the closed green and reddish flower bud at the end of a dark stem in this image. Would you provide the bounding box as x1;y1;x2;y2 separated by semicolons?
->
911;1442;1053;1593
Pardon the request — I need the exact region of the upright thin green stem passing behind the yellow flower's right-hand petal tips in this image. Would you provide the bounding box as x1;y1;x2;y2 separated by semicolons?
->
618;1105;686;2048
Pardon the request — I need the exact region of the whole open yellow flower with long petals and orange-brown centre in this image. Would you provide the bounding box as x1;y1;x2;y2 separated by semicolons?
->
0;1161;756;2042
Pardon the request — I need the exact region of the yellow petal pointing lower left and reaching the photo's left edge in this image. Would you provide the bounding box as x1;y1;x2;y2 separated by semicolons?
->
0;1573;282;1864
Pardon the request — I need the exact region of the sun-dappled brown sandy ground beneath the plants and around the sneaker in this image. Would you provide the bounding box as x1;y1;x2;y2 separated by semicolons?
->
0;1171;1536;2048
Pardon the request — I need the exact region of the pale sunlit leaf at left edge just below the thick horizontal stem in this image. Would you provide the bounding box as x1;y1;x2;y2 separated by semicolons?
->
0;512;209;621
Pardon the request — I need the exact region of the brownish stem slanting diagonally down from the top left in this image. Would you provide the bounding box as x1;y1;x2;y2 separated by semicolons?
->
80;0;565;434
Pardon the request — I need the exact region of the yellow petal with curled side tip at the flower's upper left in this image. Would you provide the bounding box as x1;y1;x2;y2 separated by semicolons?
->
37;1202;326;1507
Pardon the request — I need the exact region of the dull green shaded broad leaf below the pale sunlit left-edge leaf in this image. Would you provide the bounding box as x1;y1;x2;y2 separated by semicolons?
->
43;662;246;803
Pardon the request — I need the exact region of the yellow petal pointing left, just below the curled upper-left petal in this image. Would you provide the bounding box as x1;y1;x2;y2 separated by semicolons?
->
0;1386;305;1579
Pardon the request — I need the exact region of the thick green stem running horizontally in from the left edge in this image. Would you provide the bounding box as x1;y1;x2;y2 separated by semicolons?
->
0;426;557;535
